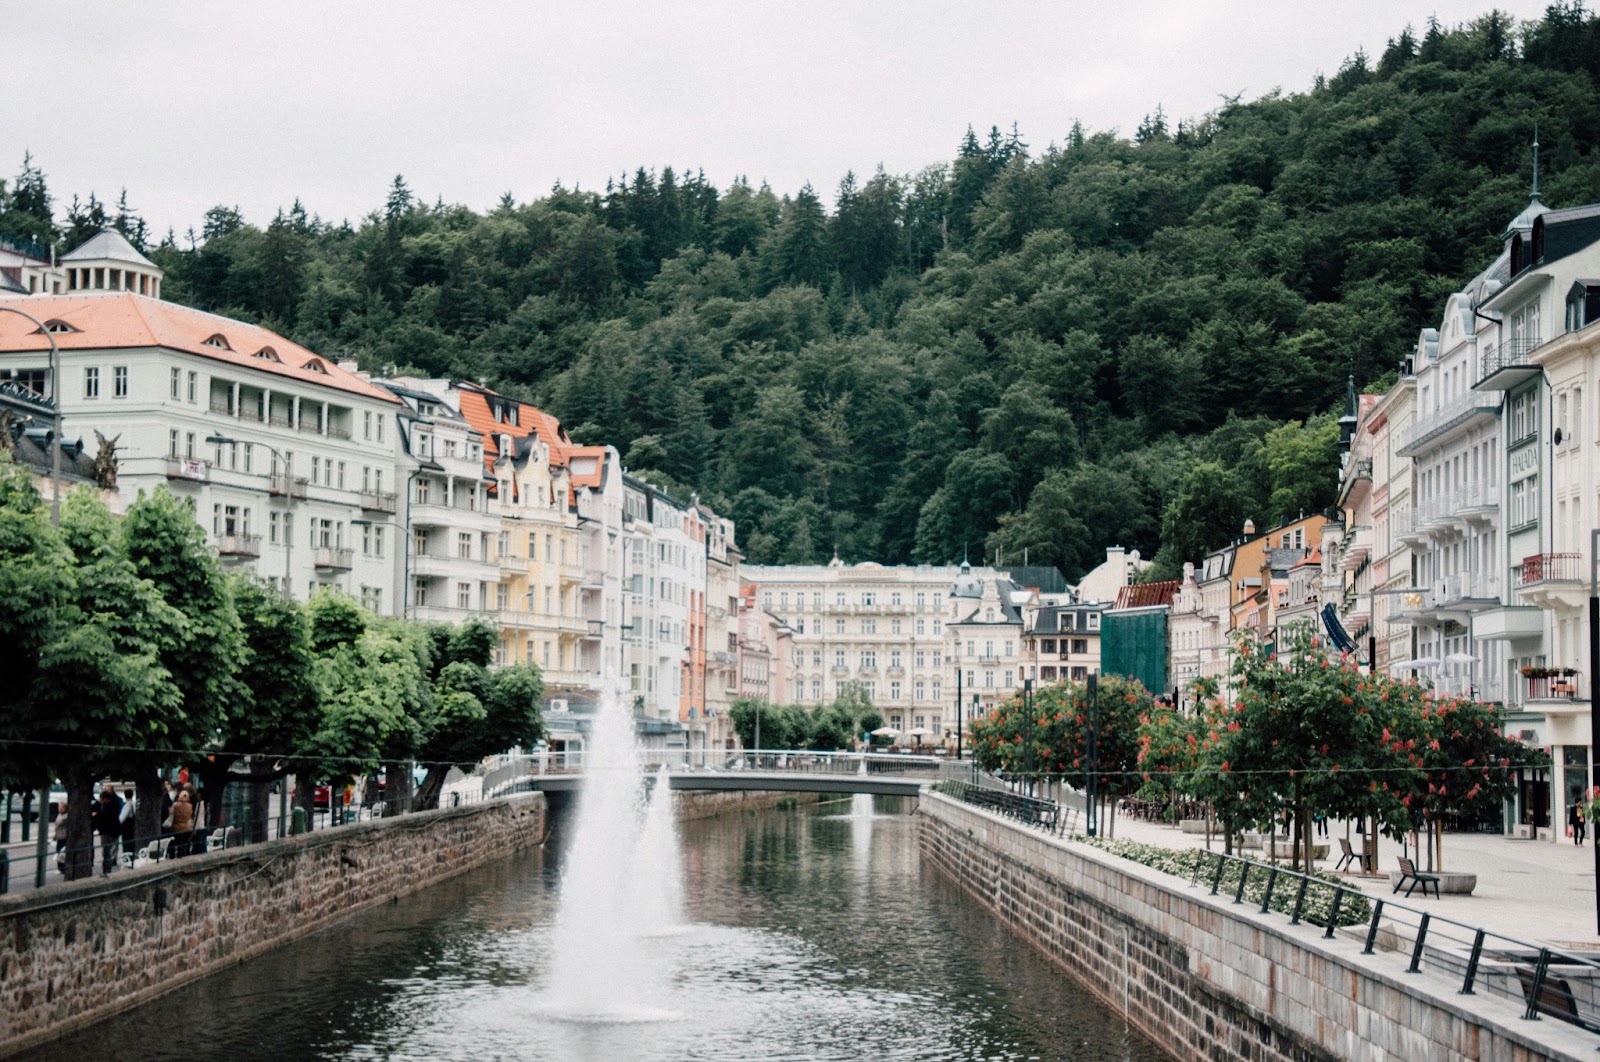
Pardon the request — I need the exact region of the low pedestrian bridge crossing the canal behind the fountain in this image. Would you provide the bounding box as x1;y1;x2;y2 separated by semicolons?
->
483;750;954;797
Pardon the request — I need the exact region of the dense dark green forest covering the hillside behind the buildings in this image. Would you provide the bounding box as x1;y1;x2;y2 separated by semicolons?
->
0;3;1600;576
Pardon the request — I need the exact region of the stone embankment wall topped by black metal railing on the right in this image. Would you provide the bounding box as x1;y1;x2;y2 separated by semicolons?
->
918;793;1597;1062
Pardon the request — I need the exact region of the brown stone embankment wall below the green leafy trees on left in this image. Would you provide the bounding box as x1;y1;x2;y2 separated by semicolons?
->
0;793;544;1056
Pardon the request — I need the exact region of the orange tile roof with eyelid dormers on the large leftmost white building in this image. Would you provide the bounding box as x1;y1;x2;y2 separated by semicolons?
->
0;291;400;405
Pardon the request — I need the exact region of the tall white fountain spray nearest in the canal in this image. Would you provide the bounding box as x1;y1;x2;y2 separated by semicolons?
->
547;696;680;1022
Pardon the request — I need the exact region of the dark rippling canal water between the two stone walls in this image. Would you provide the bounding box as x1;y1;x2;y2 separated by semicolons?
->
27;798;1165;1062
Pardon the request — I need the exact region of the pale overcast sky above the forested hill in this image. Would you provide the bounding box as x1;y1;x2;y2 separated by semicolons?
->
0;0;1547;234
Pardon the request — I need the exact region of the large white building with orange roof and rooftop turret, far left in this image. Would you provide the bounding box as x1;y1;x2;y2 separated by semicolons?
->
0;279;400;604
